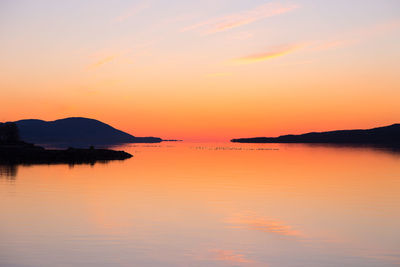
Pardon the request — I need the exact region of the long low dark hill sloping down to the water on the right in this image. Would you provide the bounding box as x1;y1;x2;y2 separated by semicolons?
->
231;124;400;145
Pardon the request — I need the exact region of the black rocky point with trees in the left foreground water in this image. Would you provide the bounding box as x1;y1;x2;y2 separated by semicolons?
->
0;122;132;164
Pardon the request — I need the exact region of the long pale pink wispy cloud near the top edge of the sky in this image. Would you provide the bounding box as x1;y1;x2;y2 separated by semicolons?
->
182;2;298;34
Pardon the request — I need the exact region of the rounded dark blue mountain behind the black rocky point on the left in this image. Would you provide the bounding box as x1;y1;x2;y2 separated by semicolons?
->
15;117;162;145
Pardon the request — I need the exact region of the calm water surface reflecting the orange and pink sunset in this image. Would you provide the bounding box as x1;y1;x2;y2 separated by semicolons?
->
0;142;400;267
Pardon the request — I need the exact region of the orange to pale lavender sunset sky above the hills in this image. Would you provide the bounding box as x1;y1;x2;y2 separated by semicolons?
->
0;0;400;141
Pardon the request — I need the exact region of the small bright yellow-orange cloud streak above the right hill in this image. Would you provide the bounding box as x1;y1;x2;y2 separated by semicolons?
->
233;45;303;64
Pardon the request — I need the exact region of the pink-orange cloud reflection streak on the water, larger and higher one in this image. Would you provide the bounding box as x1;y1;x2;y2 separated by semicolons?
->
226;214;304;237
